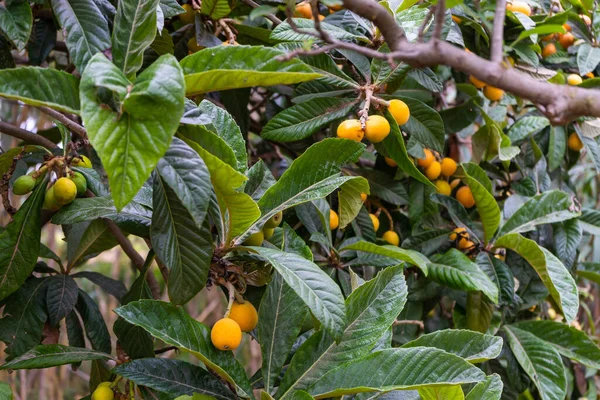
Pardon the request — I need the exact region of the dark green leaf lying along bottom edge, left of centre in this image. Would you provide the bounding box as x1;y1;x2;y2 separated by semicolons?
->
112;358;237;400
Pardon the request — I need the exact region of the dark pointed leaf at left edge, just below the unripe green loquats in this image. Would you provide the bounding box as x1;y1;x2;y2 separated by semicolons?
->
0;178;47;300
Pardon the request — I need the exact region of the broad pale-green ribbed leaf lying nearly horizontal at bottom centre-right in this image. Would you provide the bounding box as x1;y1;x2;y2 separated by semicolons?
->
308;347;485;399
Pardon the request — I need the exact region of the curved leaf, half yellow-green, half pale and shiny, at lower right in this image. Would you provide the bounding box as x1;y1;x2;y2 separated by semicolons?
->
495;233;579;323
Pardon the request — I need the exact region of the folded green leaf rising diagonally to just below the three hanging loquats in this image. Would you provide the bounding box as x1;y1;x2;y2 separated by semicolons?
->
235;138;365;244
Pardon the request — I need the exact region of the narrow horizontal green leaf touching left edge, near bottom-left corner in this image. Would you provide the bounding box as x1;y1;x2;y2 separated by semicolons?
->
0;344;114;370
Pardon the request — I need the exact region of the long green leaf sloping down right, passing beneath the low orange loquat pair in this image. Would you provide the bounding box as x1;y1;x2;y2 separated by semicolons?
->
115;300;252;397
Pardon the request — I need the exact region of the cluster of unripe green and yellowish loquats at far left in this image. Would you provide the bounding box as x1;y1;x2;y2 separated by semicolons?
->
12;156;92;211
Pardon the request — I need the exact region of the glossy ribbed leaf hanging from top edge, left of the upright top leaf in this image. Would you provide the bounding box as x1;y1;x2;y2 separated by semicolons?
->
52;0;111;74
